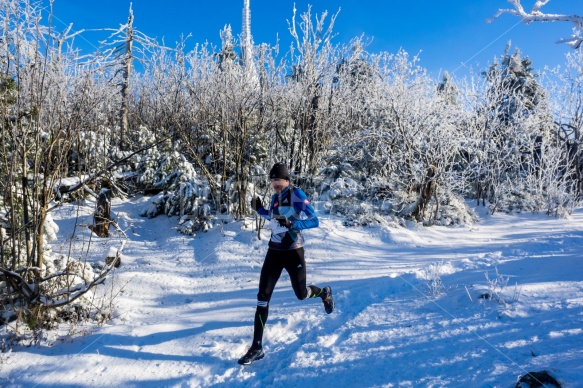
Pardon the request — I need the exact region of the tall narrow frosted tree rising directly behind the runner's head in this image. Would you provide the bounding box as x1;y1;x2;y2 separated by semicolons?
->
284;3;337;174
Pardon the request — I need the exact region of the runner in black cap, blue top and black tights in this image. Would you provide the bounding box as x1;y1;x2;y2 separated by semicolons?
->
239;163;334;365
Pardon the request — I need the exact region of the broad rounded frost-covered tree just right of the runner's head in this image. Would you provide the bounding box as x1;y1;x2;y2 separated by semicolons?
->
314;41;470;223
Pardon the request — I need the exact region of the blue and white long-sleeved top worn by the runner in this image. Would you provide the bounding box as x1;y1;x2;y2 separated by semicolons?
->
257;185;320;250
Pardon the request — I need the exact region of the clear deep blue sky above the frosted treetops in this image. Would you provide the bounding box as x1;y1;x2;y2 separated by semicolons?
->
44;0;581;76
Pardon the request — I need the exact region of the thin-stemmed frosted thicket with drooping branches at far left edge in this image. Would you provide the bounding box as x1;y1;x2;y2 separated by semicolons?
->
0;1;123;328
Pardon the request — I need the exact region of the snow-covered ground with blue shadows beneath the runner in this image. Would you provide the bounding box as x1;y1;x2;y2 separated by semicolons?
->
0;197;583;388
